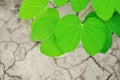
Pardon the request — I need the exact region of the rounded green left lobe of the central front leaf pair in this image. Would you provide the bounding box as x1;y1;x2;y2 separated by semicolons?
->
56;14;81;52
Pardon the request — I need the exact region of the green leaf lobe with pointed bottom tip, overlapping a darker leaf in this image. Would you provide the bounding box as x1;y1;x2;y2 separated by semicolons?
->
81;17;106;56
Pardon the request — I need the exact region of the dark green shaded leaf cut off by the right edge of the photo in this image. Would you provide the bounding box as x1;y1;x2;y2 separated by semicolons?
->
106;13;120;37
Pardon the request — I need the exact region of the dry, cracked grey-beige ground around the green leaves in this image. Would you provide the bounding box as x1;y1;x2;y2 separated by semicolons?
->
0;0;120;80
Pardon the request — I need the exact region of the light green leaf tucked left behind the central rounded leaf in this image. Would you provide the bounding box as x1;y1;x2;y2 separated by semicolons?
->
31;17;59;41
